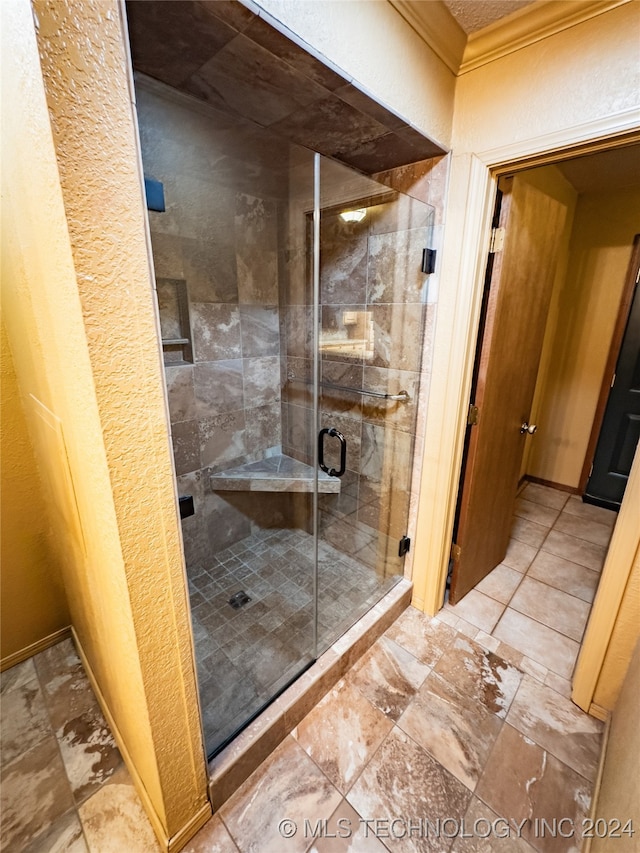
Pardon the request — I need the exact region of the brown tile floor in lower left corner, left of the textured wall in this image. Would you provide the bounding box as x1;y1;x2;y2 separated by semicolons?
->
0;640;158;853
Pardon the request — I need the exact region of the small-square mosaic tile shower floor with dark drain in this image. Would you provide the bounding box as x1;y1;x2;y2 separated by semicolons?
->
188;529;398;752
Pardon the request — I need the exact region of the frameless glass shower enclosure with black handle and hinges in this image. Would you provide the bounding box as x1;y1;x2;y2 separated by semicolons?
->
136;75;433;756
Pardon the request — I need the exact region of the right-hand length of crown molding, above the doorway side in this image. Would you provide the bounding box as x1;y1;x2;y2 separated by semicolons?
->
458;0;630;74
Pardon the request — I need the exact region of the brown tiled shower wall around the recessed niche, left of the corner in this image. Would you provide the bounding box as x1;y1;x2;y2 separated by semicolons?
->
137;76;300;565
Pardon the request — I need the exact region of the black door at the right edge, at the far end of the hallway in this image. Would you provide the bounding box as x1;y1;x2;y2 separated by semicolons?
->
584;235;640;510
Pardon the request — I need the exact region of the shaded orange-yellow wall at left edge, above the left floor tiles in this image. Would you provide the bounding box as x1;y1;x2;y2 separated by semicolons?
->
0;324;69;664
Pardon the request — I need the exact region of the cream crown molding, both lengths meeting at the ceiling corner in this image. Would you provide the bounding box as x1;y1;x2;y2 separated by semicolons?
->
389;0;632;76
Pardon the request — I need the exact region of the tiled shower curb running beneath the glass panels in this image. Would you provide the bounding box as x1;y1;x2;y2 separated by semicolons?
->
209;578;413;811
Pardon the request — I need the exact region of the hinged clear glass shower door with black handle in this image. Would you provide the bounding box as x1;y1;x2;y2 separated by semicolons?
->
317;158;433;653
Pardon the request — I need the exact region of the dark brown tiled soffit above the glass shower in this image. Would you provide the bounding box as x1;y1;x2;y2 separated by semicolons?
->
127;0;445;173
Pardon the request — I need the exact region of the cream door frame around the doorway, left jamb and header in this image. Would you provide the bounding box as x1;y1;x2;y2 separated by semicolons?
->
412;110;640;704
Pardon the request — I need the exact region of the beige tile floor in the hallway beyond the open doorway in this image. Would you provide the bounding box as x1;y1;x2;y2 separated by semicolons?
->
440;483;617;696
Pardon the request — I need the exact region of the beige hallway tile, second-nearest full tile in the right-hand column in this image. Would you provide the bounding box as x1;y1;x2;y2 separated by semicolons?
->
509;575;591;644
